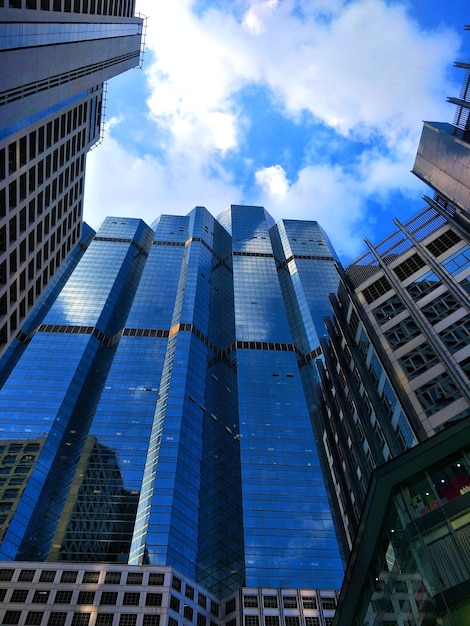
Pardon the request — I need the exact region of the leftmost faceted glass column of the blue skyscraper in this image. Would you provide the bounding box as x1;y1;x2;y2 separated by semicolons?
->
0;220;152;560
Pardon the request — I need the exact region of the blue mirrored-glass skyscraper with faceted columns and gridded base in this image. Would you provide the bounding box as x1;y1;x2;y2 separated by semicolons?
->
0;206;343;626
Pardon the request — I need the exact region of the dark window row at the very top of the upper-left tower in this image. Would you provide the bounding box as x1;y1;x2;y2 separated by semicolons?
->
0;0;135;17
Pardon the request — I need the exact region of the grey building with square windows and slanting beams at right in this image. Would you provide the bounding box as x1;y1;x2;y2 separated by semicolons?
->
320;31;470;551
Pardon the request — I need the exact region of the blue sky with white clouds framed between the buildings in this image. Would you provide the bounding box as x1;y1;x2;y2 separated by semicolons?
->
84;0;470;264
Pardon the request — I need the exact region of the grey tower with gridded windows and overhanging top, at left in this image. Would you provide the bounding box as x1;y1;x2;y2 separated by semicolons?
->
0;0;142;354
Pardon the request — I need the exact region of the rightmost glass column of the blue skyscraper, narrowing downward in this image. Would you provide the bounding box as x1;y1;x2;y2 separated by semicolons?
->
271;220;343;588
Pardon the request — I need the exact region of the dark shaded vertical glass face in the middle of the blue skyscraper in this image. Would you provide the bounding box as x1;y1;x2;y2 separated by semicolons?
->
197;222;245;598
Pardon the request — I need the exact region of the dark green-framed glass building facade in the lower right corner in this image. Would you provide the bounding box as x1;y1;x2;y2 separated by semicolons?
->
334;418;470;626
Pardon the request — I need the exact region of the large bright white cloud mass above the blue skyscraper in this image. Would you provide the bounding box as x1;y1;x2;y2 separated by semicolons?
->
86;0;459;255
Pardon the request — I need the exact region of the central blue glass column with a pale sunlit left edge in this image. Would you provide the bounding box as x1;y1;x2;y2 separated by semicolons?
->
130;207;218;578
